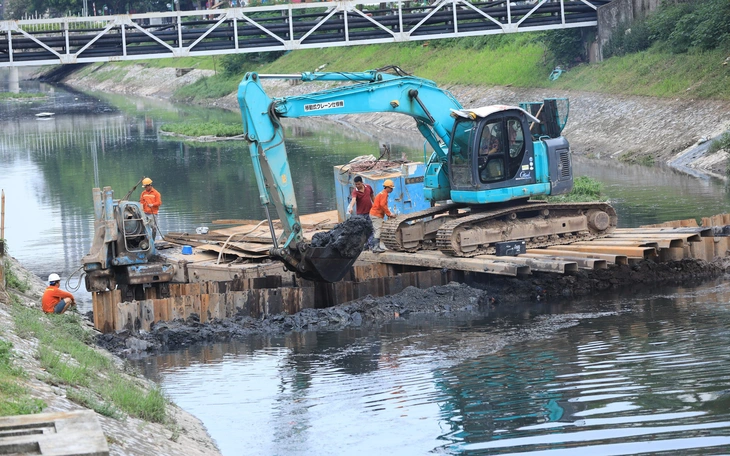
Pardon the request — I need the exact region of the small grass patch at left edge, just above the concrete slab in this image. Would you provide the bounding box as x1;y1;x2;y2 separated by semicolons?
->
0;339;46;416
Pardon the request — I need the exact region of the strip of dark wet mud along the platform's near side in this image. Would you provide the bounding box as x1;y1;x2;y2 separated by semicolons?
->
97;259;730;357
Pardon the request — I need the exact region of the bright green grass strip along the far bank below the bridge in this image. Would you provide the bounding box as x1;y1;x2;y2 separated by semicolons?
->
122;33;730;101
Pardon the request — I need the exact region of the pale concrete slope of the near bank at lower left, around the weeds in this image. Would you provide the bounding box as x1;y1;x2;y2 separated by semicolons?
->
0;256;220;456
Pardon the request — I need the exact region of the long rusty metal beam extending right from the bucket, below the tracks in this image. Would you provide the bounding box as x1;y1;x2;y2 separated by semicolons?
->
360;250;530;277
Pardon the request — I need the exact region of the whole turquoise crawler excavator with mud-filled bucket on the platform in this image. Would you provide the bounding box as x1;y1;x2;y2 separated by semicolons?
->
238;67;617;282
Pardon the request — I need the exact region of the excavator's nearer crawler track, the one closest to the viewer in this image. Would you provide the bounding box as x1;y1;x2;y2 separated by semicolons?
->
436;201;618;257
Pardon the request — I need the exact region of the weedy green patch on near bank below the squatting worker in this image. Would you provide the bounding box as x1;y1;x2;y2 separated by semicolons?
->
12;305;167;424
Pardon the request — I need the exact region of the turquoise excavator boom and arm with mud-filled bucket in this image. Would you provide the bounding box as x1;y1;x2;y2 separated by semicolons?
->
238;70;461;281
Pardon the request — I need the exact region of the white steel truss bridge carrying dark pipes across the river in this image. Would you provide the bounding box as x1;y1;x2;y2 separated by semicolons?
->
0;0;611;68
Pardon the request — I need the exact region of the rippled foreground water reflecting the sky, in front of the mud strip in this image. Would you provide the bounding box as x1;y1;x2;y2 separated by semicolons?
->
132;283;730;455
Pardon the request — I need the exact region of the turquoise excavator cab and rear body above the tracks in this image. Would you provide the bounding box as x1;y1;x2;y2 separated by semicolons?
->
449;103;573;204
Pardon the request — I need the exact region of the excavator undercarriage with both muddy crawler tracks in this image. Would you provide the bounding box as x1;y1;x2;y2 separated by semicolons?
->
381;201;618;257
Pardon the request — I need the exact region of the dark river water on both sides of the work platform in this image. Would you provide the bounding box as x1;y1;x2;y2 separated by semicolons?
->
0;75;730;455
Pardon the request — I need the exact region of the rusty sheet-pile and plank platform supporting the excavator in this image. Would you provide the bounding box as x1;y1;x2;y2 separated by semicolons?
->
93;211;730;332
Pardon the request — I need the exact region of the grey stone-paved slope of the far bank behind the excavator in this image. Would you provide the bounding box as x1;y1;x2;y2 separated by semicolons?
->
64;65;730;179
